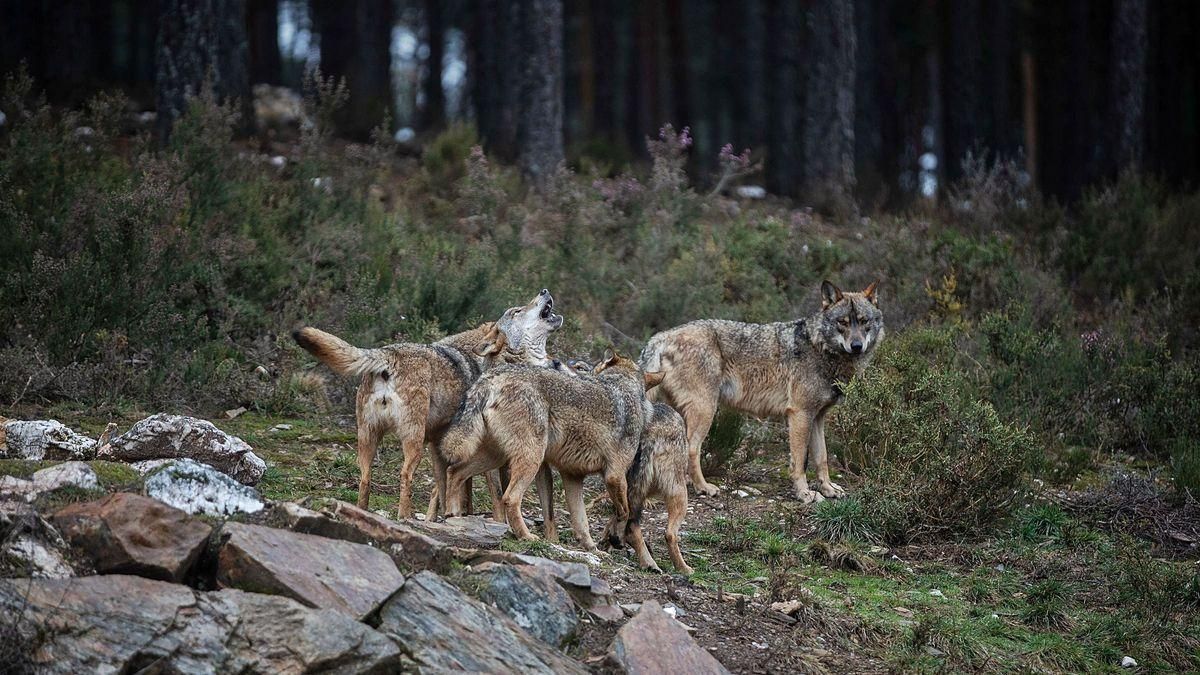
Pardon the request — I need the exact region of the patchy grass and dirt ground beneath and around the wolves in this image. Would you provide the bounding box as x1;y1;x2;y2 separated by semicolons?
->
7;401;1198;673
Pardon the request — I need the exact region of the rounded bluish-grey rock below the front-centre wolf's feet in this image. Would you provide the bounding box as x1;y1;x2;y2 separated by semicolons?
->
468;562;580;647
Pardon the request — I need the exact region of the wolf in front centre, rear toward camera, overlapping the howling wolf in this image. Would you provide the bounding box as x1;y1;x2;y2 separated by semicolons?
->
440;351;646;551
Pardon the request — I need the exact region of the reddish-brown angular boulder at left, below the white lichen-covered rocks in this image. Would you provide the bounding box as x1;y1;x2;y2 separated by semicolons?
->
53;492;212;581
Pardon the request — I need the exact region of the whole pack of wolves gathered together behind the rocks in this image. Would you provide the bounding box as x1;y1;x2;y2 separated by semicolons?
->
293;281;884;574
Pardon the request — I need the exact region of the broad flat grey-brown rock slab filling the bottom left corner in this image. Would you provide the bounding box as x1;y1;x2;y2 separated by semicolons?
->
0;575;404;674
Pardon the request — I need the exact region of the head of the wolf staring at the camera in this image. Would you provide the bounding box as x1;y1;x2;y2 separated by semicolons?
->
808;281;883;356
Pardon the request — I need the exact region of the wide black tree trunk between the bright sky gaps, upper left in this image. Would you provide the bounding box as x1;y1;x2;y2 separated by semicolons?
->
311;0;394;141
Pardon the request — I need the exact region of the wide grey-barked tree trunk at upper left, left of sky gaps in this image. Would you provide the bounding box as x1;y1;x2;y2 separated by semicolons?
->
155;0;251;142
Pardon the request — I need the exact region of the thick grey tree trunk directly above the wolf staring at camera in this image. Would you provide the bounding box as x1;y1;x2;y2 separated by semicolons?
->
800;0;856;209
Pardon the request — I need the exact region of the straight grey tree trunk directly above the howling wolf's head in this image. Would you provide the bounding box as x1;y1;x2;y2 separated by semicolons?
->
517;0;564;189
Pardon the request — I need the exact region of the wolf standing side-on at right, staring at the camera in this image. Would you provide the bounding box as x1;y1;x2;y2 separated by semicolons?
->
641;281;883;503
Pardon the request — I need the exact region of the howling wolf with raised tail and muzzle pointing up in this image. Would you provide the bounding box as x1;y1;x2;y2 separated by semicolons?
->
293;288;563;518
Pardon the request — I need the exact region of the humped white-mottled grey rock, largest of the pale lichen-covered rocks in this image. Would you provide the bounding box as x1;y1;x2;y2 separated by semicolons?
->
97;413;266;485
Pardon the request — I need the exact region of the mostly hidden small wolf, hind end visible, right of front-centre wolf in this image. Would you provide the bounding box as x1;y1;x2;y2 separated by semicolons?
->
604;396;692;575
